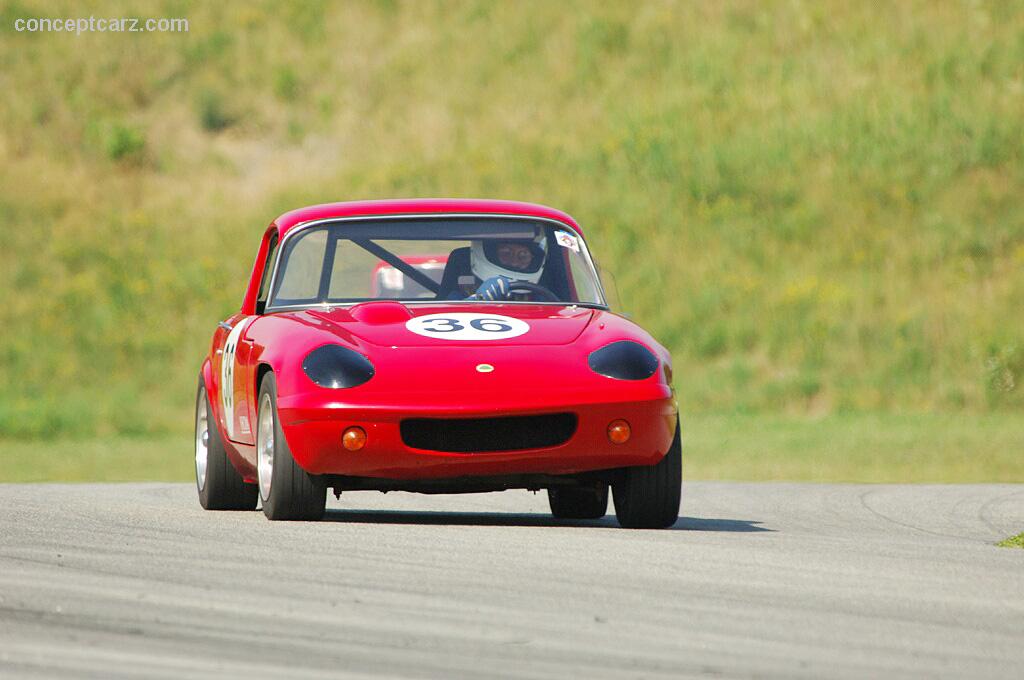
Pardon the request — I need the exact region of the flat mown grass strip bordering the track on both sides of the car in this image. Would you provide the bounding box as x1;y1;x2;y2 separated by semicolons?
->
0;414;1024;482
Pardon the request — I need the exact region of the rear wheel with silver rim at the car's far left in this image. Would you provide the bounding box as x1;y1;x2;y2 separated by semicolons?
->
196;376;259;510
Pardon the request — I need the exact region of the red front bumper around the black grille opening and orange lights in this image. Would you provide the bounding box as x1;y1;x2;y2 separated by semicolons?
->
278;388;677;479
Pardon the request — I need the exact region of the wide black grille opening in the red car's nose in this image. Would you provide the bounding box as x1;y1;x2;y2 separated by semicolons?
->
399;413;577;454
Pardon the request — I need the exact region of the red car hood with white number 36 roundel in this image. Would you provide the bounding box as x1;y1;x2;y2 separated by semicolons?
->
286;301;594;347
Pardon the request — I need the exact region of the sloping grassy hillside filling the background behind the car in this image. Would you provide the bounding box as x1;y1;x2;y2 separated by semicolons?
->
0;1;1024;441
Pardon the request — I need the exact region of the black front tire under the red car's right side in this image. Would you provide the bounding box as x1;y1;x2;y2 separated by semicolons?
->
611;419;683;528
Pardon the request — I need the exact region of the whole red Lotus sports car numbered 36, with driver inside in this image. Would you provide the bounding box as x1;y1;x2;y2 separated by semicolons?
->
196;200;681;528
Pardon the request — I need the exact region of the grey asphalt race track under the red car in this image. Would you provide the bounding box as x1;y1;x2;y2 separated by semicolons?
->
0;482;1024;678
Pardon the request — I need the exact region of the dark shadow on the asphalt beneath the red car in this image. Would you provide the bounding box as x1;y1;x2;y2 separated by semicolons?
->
323;509;774;533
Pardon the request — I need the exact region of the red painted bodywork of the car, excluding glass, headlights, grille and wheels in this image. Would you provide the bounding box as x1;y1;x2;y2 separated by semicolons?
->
203;200;676;480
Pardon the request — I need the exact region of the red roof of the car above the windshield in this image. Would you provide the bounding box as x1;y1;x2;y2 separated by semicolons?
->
273;199;583;238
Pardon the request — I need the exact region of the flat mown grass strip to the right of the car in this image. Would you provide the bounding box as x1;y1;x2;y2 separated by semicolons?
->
682;413;1024;483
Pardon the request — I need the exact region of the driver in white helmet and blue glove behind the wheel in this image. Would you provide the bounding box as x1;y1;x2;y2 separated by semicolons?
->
467;233;548;300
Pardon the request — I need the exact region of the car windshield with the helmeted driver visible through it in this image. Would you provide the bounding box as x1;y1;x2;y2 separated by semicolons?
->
267;217;605;309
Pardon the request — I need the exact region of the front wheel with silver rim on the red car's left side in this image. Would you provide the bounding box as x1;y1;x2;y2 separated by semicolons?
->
256;373;327;521
